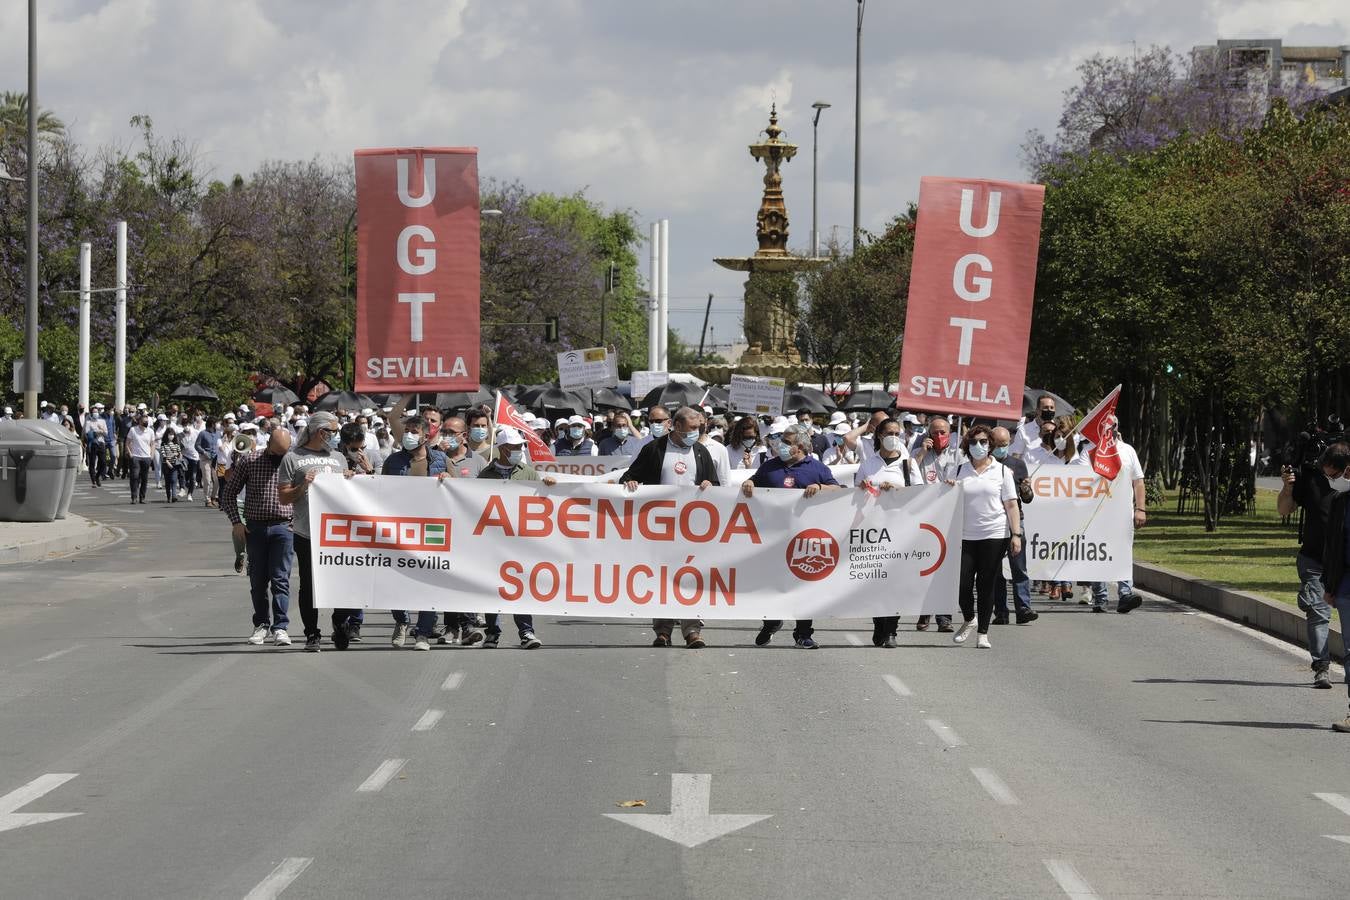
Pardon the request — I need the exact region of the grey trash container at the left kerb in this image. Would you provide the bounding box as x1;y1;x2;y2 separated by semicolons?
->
0;420;74;522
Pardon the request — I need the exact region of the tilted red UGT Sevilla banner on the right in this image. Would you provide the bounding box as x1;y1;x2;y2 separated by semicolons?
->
896;178;1045;420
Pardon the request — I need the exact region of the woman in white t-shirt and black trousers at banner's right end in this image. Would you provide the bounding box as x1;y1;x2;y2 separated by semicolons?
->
950;425;1022;649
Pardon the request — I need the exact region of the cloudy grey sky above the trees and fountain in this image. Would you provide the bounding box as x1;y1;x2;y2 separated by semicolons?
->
0;0;1350;344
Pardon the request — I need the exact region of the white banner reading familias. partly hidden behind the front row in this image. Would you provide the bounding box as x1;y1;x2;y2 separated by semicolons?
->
1022;466;1134;582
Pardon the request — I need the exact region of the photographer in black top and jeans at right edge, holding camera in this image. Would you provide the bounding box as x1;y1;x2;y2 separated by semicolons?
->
1276;441;1350;690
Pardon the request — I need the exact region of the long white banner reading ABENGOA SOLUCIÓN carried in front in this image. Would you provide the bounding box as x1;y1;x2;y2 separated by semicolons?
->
309;475;961;619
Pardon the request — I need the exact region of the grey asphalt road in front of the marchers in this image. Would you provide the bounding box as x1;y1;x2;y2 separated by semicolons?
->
0;482;1350;899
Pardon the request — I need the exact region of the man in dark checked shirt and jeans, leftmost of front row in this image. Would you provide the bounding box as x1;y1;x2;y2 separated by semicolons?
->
220;428;294;646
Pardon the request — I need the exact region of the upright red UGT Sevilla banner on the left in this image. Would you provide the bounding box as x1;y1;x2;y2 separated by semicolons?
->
356;147;479;394
